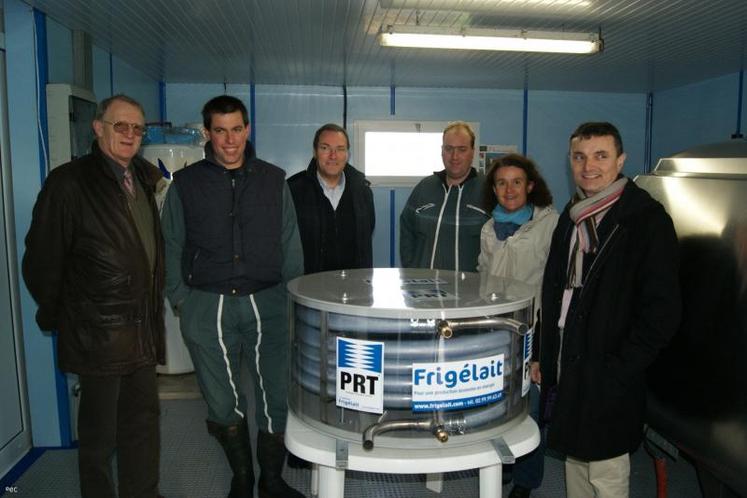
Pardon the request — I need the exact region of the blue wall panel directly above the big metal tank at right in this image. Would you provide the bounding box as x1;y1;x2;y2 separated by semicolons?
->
652;73;744;161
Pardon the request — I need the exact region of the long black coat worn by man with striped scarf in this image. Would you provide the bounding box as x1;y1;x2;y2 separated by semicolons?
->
540;181;681;461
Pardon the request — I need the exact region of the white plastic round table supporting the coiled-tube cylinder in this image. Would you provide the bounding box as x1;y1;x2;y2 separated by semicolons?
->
285;412;540;498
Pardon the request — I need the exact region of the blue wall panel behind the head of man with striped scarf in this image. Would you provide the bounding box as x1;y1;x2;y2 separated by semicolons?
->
527;91;646;210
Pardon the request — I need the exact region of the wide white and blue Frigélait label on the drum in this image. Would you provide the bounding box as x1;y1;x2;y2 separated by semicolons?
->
412;354;504;412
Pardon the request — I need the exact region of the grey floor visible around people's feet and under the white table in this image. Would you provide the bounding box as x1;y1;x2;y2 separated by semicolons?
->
7;376;702;498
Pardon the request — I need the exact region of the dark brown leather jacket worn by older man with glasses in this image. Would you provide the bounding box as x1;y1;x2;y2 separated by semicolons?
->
23;144;164;375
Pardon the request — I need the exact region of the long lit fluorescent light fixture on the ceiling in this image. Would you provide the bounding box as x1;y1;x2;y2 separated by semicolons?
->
379;26;602;54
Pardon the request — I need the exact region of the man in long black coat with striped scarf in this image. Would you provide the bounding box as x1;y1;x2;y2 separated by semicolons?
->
540;123;681;498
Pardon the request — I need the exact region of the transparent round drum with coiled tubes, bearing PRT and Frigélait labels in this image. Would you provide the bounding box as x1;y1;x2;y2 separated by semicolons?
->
288;268;533;449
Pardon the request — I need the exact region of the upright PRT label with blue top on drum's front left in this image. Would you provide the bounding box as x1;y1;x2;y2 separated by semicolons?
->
336;337;384;413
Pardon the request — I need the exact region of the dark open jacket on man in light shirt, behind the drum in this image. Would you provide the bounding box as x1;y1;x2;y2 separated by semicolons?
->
288;158;376;274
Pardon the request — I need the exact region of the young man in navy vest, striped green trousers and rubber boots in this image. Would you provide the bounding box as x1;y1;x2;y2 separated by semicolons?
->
163;95;303;498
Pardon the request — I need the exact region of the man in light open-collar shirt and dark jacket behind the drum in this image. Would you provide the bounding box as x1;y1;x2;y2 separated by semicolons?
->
288;123;376;274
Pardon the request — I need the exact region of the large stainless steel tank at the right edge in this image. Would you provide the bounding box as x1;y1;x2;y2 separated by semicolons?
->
635;140;747;497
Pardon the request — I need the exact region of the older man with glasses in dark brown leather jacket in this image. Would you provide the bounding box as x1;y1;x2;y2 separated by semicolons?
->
23;95;164;498
